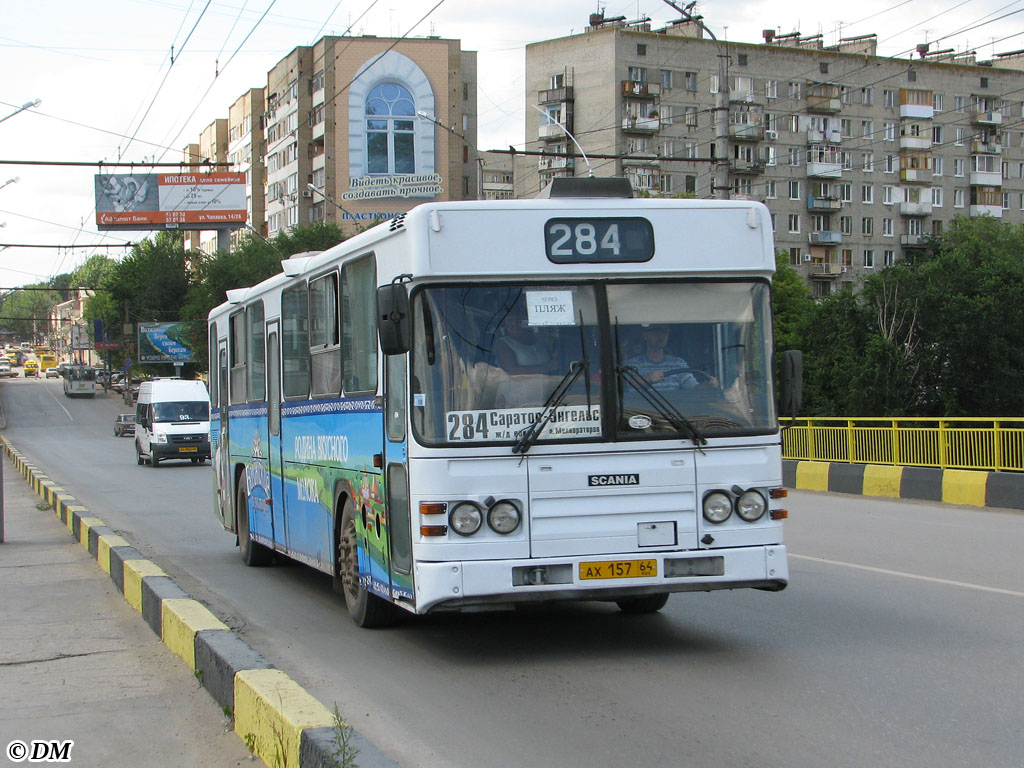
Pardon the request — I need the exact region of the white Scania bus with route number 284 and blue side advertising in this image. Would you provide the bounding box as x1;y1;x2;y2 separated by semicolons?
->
209;179;788;627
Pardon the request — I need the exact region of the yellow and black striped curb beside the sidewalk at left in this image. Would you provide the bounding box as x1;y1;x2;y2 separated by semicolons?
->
0;436;399;768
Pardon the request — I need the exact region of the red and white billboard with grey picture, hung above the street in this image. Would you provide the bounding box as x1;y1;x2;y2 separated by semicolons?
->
93;171;246;231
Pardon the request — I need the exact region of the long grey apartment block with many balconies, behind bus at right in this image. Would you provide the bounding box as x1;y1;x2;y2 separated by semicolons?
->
515;13;1024;296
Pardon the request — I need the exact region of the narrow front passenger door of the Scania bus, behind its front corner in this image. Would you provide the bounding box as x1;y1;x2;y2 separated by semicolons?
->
382;354;416;606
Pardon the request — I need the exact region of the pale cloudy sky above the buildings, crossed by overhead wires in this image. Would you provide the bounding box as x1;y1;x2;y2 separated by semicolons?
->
0;0;1024;291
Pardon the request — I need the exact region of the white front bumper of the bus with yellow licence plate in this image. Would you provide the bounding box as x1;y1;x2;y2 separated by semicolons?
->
415;545;790;613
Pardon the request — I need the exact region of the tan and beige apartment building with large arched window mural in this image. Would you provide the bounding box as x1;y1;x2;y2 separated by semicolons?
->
262;37;479;238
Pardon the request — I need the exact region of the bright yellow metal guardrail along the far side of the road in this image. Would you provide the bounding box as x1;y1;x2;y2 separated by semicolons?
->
781;418;1024;472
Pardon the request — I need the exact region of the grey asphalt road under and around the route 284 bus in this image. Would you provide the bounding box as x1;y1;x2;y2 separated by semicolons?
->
0;380;1024;768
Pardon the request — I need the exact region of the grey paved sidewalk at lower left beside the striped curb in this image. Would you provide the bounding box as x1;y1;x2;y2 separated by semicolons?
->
0;454;253;768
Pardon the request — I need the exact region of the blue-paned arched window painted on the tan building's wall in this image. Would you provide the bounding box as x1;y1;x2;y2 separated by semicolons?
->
367;83;416;174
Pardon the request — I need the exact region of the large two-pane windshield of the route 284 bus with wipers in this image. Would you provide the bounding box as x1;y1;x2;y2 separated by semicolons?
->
411;280;776;445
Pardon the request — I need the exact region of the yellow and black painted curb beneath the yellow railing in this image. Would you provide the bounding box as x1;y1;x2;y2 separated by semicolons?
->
782;459;1024;509
